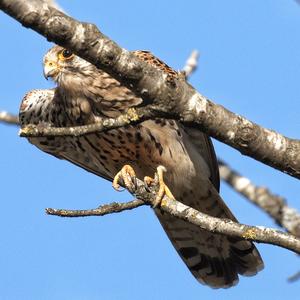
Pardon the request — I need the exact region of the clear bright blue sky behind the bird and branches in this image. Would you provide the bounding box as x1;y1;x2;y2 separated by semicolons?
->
0;0;300;300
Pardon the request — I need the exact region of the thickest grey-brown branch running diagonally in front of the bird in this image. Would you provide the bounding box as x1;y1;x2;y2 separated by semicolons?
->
0;0;300;178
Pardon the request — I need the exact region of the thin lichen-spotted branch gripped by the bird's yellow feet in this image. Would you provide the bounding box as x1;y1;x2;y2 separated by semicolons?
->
46;175;300;254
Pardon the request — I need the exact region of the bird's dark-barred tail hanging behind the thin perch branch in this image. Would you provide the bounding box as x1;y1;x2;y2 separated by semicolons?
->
155;185;264;288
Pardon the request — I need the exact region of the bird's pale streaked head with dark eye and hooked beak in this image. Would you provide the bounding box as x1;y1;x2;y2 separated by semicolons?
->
43;46;95;87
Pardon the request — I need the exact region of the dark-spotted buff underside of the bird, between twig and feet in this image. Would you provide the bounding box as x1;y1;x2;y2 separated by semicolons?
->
31;119;204;193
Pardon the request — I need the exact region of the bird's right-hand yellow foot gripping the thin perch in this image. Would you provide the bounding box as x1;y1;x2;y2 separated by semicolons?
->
144;166;175;208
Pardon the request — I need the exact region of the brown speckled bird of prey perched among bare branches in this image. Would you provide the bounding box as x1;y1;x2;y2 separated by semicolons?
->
19;45;264;288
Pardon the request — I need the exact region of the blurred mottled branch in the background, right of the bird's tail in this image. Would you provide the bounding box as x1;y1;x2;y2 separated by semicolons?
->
219;159;300;237
